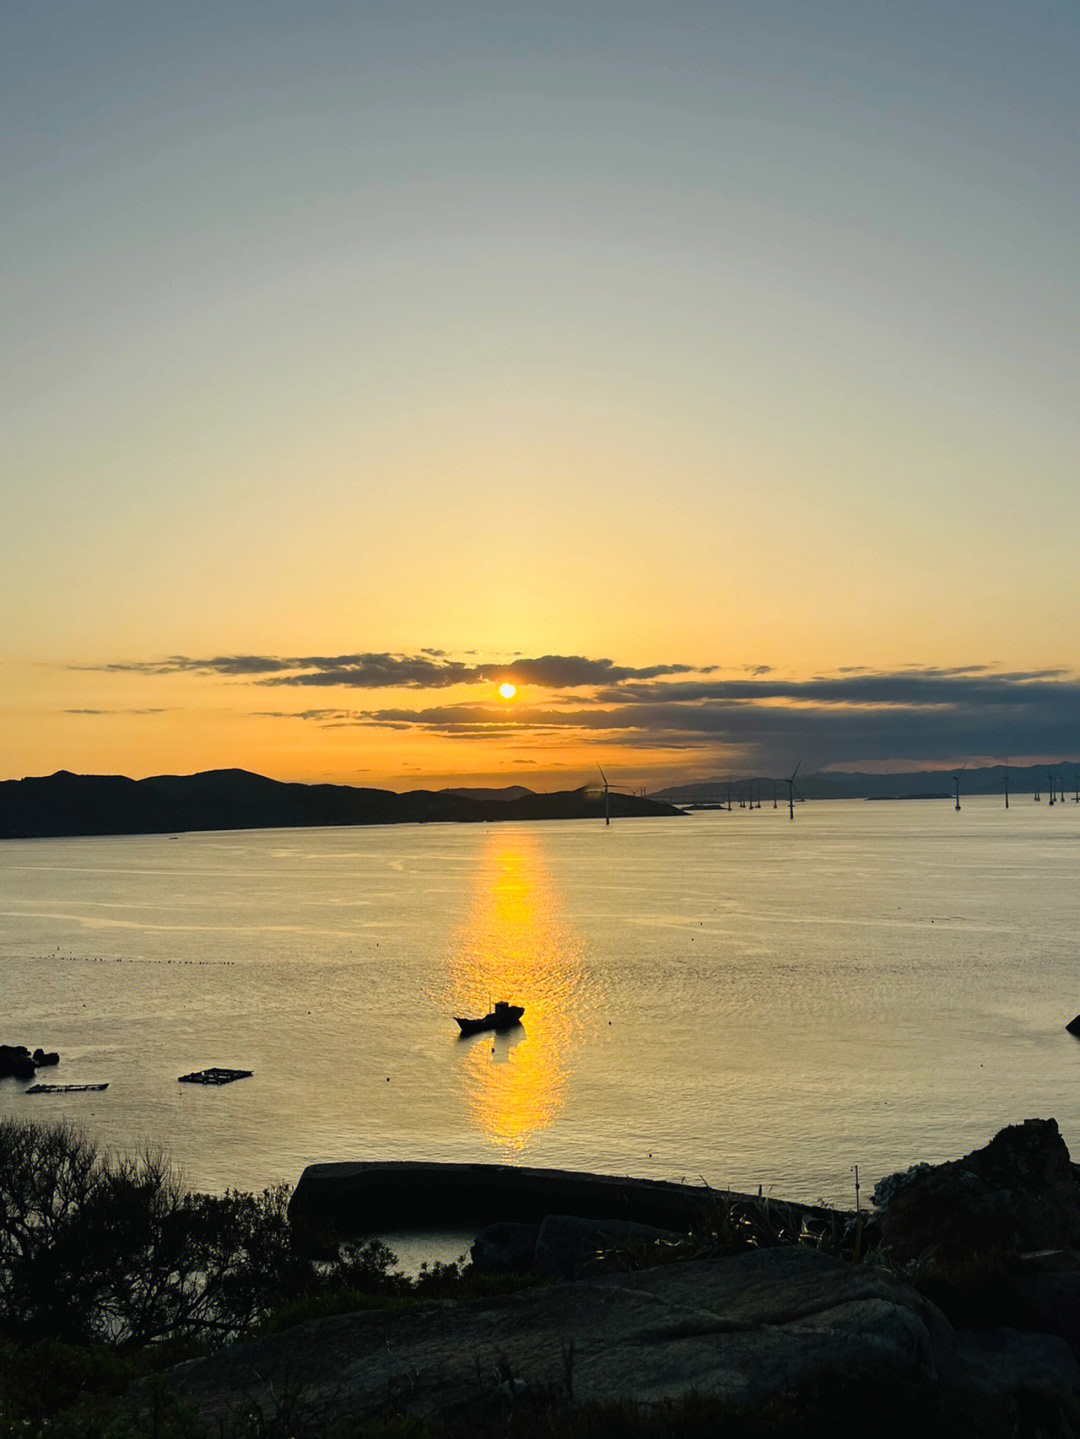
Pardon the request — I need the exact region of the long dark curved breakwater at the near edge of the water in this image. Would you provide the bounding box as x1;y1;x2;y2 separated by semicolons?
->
289;1160;847;1256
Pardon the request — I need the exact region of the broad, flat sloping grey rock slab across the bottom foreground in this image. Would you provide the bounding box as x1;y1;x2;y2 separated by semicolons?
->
156;1246;1080;1433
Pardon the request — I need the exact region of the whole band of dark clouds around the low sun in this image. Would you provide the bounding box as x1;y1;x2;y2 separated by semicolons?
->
82;648;1080;773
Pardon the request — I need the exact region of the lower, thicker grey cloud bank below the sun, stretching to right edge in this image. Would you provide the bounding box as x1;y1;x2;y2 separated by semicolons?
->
255;665;1080;770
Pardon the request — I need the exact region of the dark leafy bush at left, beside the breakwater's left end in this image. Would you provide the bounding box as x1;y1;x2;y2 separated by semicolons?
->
0;1120;400;1347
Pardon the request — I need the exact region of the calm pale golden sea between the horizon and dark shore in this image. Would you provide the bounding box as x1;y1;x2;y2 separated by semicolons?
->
0;796;1080;1203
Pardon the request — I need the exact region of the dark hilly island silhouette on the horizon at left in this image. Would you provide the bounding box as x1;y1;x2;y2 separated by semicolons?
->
0;770;682;839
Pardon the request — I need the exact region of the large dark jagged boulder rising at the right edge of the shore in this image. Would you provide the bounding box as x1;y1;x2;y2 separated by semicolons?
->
873;1120;1080;1262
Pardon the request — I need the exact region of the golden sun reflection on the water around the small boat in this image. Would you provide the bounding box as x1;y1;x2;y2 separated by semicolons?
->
450;826;594;1150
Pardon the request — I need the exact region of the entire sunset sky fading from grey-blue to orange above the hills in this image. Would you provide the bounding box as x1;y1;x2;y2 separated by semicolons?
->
0;0;1080;789
